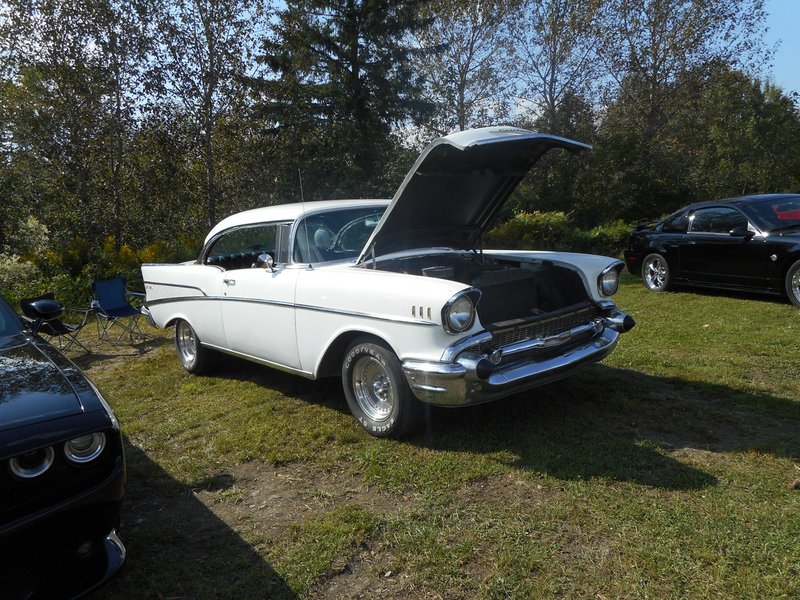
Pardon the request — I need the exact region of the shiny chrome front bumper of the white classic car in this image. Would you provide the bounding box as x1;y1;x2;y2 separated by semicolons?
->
403;308;635;406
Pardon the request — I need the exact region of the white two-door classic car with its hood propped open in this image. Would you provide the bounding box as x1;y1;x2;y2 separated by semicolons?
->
142;128;634;437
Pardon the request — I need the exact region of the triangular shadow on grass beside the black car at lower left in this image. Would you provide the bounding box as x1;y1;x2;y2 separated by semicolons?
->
91;440;297;600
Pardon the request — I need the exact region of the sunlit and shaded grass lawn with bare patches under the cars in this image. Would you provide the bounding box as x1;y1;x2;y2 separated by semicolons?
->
81;276;800;599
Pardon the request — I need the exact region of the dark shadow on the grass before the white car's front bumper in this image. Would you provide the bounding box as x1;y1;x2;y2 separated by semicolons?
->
412;365;800;490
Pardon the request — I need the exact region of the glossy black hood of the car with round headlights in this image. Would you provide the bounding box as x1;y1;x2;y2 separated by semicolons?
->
0;334;87;431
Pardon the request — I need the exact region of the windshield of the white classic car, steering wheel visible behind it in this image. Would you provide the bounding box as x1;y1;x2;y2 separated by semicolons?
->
293;206;386;263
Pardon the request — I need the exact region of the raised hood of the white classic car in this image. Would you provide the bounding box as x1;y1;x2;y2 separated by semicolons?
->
358;127;591;263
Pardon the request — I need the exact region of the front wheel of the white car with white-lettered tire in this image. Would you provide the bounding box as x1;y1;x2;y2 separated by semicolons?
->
342;339;422;438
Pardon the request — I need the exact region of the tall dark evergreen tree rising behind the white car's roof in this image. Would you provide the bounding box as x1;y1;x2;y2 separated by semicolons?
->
252;0;434;202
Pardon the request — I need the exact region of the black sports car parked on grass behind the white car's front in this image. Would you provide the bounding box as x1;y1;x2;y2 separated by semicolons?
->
625;194;800;307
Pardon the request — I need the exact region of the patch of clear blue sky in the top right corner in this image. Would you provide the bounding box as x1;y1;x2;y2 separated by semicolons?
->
764;0;800;94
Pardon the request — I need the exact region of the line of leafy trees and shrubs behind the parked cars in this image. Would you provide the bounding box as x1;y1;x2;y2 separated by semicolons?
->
0;0;800;300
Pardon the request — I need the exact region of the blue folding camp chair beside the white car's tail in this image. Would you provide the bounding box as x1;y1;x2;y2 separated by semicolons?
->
92;277;146;344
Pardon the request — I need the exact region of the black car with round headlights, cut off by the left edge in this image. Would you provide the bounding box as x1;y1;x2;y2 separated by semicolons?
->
0;298;125;600
